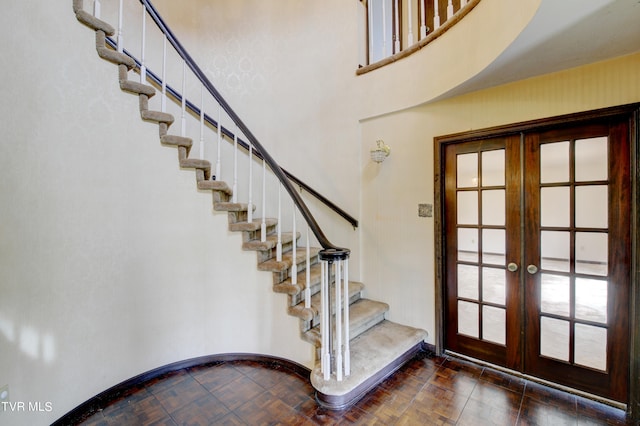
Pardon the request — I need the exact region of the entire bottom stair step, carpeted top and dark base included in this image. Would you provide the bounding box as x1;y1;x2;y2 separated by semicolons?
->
311;320;427;410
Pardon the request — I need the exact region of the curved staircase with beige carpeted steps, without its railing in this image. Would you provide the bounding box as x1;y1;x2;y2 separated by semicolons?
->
73;0;426;409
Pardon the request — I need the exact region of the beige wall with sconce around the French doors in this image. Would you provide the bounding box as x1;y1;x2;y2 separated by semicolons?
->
361;50;640;343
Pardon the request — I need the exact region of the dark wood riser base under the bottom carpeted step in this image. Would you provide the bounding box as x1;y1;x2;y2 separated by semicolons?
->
316;342;429;411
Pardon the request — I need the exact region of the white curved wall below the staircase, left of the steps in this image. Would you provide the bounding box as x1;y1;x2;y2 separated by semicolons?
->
0;4;313;425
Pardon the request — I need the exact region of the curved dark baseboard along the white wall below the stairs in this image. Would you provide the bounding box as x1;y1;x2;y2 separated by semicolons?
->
52;353;311;426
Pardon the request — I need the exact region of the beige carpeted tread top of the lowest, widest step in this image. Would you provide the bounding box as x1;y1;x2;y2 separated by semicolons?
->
311;320;427;400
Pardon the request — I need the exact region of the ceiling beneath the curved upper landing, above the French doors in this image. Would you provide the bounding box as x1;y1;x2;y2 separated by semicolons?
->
439;0;640;99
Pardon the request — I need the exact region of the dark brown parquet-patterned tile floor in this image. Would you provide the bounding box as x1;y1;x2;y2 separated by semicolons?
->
75;354;627;426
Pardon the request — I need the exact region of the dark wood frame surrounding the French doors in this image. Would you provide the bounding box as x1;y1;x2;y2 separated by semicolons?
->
434;103;640;422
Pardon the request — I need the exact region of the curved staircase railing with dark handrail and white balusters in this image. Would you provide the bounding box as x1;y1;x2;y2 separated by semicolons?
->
81;0;350;380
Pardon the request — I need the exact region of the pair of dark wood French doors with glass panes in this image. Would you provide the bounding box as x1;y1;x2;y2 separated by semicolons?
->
442;118;631;402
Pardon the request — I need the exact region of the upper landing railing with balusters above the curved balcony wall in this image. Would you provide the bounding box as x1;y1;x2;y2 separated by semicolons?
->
357;0;480;74
